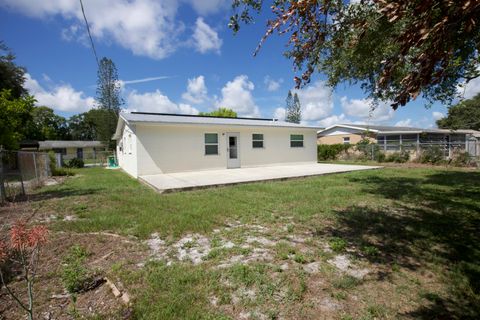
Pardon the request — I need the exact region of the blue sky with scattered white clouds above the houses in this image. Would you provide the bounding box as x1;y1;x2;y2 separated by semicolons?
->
0;0;480;127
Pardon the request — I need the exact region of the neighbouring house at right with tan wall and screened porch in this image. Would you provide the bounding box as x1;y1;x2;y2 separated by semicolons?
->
318;124;480;156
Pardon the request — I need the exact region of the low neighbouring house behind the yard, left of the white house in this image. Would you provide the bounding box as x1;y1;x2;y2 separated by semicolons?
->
20;140;106;160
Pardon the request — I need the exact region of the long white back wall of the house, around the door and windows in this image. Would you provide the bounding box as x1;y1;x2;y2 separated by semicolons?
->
133;124;317;176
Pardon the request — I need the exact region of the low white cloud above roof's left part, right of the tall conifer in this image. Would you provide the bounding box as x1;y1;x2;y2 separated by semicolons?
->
126;90;198;114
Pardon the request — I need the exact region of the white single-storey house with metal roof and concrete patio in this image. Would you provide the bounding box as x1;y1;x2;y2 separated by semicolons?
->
113;112;318;177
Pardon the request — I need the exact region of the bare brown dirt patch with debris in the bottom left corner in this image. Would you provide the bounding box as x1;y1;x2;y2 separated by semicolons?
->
0;233;148;319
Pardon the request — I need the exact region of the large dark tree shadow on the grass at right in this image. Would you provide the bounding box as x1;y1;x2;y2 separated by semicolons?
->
327;171;480;319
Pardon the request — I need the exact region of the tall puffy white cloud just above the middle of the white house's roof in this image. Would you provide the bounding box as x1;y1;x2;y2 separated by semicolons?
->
216;75;260;117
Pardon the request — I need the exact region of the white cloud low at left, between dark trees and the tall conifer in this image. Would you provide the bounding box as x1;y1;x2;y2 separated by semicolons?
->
25;73;95;112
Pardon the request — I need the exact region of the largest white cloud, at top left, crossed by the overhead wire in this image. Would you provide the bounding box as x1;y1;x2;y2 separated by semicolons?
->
0;0;184;59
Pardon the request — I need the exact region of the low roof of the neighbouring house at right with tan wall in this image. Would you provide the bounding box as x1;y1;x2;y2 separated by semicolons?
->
318;124;480;136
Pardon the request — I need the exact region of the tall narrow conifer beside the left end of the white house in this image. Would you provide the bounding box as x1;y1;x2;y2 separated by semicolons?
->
91;57;123;148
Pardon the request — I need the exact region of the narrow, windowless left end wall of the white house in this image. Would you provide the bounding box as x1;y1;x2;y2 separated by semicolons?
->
117;125;138;178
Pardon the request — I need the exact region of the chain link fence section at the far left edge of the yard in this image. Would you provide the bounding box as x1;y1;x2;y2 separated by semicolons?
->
0;150;51;203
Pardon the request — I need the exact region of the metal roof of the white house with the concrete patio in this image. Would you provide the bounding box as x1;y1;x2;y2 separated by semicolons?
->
113;112;320;139
